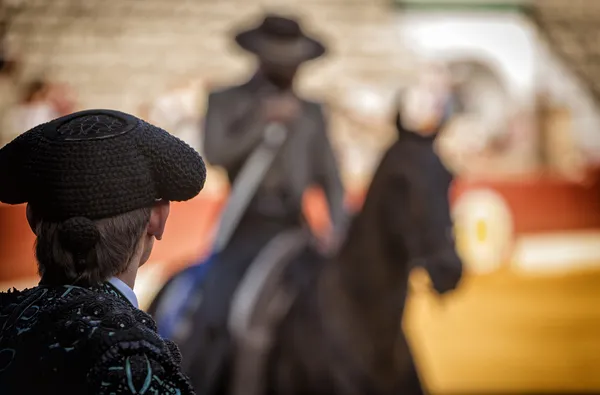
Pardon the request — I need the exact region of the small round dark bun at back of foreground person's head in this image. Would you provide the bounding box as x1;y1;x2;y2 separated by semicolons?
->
58;217;100;254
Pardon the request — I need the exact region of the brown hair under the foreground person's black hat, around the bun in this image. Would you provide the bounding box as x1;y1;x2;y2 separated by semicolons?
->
32;208;151;285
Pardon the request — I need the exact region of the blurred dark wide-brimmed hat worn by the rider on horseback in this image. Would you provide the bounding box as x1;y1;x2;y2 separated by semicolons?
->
235;14;326;64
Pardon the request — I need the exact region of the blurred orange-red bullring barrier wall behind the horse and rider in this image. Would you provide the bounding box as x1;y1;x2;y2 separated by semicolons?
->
0;172;600;282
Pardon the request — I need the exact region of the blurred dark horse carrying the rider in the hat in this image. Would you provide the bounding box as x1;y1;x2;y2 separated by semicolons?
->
150;121;462;395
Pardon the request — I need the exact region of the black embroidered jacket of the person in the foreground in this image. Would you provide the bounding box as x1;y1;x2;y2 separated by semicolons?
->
0;284;194;395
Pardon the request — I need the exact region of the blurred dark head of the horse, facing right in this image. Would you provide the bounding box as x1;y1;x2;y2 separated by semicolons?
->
384;135;463;294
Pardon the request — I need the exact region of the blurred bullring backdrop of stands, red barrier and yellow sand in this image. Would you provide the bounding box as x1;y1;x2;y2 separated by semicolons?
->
0;0;600;393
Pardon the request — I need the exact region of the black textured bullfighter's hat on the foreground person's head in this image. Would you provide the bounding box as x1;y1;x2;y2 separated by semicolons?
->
0;110;206;222
